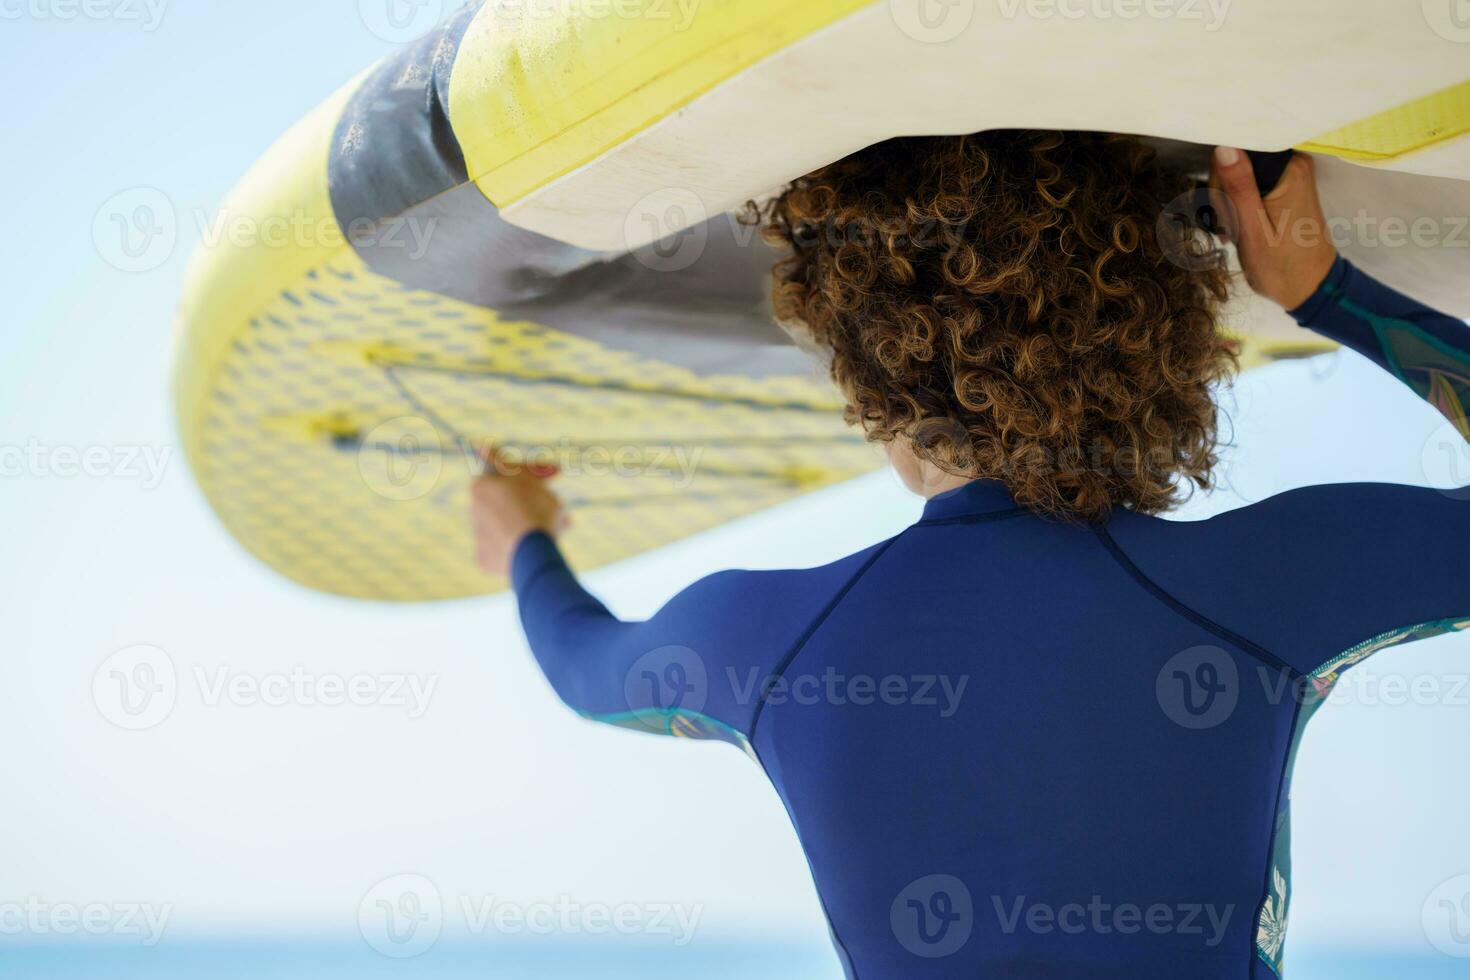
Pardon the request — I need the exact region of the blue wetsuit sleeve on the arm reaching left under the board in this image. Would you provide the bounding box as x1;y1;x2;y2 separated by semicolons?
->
512;533;869;748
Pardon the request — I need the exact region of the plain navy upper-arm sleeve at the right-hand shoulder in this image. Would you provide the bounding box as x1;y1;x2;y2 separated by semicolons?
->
1113;483;1470;676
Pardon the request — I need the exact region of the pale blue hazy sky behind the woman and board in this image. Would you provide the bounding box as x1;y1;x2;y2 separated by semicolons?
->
0;0;1470;969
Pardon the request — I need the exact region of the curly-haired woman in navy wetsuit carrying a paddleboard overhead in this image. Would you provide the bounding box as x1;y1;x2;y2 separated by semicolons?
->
475;132;1470;980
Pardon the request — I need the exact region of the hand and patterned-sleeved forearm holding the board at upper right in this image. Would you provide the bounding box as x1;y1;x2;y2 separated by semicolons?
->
1214;148;1470;438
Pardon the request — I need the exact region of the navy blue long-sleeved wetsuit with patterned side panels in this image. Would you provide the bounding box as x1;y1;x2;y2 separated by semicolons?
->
513;262;1470;980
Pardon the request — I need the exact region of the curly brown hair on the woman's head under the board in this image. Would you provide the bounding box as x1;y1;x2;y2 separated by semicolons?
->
747;131;1236;520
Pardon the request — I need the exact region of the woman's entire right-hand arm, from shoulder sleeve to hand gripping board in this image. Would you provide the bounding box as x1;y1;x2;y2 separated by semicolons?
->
1111;148;1470;683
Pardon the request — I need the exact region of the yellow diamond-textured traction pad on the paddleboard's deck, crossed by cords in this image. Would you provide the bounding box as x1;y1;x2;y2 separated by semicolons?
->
197;256;876;601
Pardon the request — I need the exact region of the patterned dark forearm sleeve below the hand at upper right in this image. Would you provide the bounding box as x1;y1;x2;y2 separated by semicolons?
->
1291;256;1470;439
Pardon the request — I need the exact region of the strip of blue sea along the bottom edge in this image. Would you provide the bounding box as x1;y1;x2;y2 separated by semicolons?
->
0;942;1470;980
